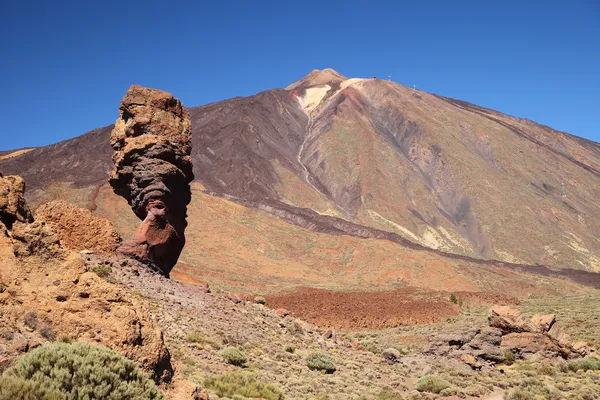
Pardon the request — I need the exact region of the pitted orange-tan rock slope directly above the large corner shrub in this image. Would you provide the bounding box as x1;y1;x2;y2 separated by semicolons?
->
0;245;173;383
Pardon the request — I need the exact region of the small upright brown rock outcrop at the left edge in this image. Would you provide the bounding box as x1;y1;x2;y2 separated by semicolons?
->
0;174;33;229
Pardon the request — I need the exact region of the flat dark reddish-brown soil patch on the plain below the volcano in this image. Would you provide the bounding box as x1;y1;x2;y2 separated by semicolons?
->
266;288;459;329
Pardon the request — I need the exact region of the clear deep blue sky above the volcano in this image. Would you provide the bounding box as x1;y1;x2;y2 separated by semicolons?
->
0;0;600;150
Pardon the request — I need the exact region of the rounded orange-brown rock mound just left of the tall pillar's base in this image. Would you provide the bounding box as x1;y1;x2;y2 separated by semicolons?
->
35;200;121;256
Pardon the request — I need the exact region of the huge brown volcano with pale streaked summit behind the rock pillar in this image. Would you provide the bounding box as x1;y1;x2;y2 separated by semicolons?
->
0;70;600;271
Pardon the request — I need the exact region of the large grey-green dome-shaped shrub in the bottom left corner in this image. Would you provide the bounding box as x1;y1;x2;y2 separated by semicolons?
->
2;342;164;400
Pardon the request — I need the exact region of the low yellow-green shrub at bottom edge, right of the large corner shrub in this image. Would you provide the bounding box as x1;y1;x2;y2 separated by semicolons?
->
204;371;285;400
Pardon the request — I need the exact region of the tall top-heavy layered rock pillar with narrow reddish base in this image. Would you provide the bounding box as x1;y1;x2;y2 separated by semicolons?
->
110;85;194;276
